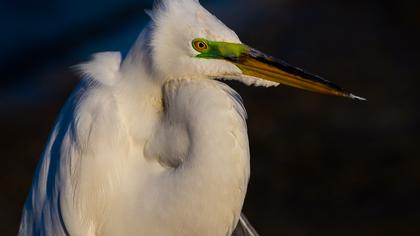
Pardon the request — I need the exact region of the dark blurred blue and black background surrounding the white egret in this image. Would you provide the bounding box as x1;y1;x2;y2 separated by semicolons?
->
0;0;420;236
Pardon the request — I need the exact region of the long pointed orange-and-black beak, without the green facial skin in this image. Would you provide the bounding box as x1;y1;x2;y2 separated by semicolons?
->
225;48;366;101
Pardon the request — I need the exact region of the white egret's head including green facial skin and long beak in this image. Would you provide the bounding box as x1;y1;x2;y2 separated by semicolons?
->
144;0;363;100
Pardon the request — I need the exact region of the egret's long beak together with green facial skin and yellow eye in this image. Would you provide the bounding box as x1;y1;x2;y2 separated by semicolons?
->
192;38;366;101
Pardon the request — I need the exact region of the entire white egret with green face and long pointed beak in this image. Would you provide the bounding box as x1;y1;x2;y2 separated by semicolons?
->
19;0;361;236
